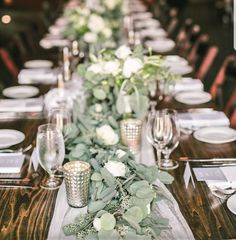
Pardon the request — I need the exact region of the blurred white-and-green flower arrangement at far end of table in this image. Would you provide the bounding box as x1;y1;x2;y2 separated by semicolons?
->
64;0;122;53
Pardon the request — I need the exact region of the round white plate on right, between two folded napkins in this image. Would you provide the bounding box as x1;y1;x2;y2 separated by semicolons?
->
175;91;211;105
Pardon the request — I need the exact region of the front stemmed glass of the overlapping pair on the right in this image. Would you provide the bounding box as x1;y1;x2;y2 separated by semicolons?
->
146;109;174;170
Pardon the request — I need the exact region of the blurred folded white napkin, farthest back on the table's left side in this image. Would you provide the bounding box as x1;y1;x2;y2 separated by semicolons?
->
18;69;57;84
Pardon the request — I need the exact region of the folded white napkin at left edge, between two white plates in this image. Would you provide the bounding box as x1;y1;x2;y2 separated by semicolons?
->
0;98;43;112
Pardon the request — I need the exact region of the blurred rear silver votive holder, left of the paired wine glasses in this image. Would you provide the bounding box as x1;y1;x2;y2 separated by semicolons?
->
120;119;142;154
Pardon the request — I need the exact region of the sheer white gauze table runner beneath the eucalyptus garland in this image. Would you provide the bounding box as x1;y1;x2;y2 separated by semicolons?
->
48;123;194;240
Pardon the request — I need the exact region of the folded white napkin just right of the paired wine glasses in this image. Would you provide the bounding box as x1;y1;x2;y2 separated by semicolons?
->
178;111;230;128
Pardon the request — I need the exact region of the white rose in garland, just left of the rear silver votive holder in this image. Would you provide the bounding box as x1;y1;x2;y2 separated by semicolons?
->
96;125;119;145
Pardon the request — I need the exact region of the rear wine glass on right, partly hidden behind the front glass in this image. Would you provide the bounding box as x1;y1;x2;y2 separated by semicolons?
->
162;109;180;170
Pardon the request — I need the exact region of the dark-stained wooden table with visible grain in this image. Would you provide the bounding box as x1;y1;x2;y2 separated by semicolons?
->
0;88;236;240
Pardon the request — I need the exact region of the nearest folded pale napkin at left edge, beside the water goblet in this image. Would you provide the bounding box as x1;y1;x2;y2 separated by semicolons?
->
0;152;25;173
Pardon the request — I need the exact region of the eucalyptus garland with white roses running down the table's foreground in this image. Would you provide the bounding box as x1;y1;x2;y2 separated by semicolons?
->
63;46;177;240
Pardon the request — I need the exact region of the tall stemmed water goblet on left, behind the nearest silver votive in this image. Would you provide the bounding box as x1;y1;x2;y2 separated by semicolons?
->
36;124;65;190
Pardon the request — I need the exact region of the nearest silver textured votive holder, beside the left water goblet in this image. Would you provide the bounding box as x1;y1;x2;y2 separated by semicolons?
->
63;161;91;208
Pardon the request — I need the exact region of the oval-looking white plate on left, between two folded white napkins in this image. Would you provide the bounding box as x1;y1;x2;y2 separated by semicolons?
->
2;86;39;98
